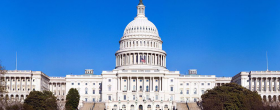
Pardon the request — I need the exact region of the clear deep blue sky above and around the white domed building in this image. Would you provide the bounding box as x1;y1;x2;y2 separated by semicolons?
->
0;0;280;77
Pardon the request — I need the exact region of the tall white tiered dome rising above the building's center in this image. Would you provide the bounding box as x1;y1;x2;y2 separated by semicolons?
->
115;0;166;70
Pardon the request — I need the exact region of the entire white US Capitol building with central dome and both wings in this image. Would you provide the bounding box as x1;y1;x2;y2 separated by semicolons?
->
1;0;280;110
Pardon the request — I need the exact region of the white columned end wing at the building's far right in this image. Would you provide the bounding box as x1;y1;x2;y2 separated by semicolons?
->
232;71;280;102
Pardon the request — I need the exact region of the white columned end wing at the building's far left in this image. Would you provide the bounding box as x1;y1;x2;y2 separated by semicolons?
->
0;70;50;101
